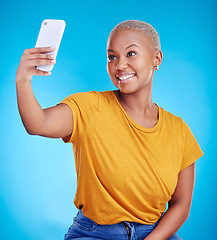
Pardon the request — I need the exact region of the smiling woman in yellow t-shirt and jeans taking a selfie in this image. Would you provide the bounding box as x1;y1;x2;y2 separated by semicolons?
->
16;20;203;240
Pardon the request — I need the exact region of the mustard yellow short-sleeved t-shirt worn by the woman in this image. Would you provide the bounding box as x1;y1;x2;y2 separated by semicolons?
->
61;91;203;224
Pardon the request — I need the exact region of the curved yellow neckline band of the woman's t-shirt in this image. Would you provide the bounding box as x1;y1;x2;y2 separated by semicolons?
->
110;91;162;133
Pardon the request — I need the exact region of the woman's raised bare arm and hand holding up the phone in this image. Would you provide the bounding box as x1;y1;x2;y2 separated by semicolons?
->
16;48;73;138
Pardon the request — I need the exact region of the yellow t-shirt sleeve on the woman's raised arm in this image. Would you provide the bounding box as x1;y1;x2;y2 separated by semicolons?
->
60;91;98;143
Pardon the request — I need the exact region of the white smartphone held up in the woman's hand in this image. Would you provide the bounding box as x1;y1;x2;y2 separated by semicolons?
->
35;19;66;72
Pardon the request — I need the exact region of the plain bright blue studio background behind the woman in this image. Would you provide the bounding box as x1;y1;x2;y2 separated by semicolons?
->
0;0;217;240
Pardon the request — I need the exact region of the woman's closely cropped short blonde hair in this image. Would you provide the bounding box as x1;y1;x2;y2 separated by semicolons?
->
109;20;161;51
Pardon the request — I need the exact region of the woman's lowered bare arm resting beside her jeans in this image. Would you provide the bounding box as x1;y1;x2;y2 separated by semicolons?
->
145;163;195;240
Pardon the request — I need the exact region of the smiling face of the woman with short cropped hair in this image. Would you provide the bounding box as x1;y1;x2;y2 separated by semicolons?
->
107;29;160;93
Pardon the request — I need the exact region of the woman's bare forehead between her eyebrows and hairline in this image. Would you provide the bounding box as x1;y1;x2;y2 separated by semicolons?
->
107;29;153;49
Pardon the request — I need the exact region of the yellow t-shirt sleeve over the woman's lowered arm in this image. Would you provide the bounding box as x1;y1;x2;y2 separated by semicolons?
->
180;122;203;171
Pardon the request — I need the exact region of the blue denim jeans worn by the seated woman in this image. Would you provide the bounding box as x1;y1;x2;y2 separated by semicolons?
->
64;210;182;240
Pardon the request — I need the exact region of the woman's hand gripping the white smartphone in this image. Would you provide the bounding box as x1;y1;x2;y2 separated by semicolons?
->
16;47;56;82
